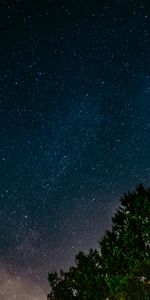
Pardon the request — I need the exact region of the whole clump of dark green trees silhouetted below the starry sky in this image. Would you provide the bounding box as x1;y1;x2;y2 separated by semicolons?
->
48;185;150;300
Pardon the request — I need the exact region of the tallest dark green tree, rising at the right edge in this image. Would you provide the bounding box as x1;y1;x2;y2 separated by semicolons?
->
100;185;150;299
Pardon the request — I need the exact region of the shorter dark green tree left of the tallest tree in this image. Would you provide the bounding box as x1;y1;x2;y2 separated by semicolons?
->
48;250;102;300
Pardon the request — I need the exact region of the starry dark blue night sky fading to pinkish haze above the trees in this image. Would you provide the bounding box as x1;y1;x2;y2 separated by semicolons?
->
0;0;150;300
